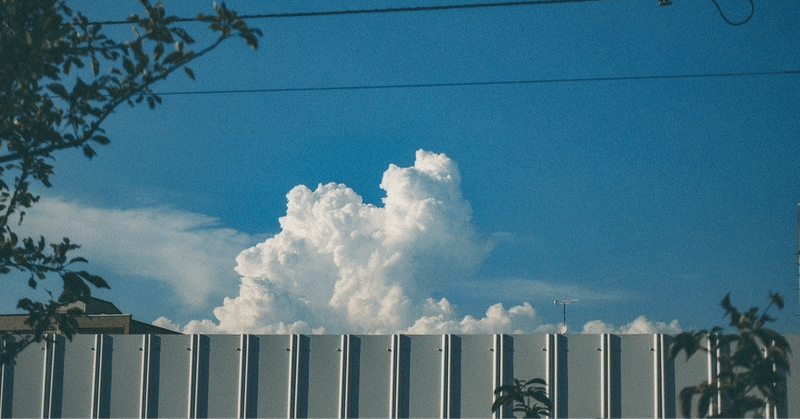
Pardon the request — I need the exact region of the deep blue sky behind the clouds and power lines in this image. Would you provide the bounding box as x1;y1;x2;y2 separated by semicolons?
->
3;0;800;333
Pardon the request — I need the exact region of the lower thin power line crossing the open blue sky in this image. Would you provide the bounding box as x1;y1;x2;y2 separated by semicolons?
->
156;70;800;96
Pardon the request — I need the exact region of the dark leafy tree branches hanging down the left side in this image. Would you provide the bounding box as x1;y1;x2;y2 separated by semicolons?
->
0;0;262;363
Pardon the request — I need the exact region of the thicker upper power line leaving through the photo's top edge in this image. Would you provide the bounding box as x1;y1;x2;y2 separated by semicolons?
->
91;0;610;25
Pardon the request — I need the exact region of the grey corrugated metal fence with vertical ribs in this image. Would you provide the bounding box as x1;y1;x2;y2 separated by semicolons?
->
0;334;800;419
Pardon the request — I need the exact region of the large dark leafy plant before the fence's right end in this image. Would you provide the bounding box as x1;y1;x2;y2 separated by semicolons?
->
669;293;791;418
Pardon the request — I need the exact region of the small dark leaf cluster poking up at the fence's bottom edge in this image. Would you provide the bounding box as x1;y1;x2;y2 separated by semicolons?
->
492;378;553;419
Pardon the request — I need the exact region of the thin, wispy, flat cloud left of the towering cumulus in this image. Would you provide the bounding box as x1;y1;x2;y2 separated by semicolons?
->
20;197;253;308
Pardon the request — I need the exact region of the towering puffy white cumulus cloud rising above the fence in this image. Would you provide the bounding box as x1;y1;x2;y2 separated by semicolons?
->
196;150;500;333
